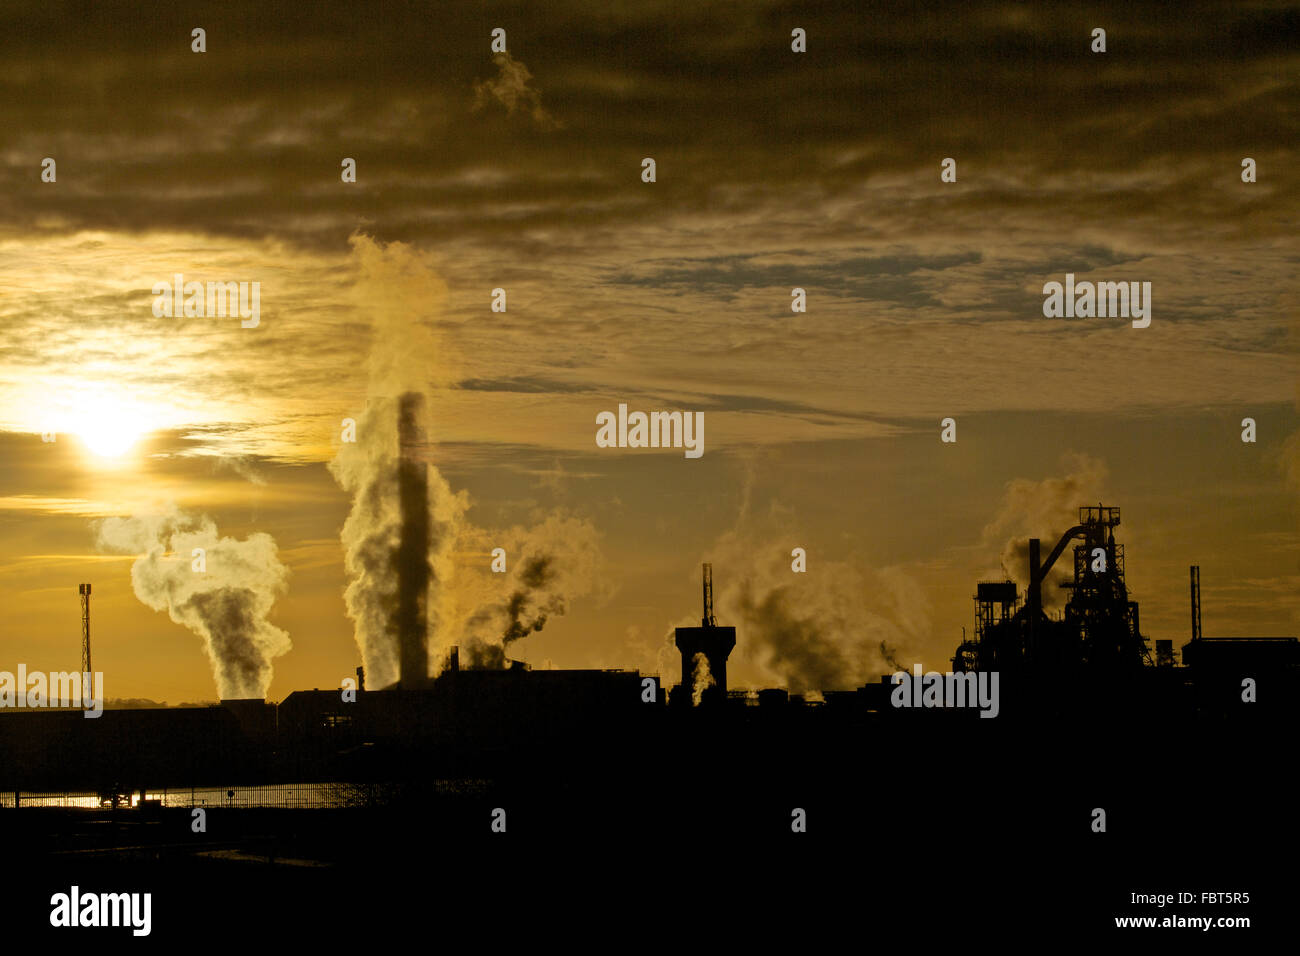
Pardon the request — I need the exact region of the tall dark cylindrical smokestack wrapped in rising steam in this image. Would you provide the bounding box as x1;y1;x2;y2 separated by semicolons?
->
398;392;430;688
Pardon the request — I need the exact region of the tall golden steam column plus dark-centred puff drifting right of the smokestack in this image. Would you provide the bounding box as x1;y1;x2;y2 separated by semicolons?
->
330;235;599;688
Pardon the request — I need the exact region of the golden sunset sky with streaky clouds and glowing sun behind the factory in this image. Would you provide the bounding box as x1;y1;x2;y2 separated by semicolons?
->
0;1;1300;704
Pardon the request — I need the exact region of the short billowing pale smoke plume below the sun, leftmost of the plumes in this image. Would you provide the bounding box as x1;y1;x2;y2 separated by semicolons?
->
99;505;291;698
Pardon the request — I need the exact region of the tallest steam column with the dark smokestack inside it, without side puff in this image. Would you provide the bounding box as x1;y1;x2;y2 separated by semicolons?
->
330;235;467;687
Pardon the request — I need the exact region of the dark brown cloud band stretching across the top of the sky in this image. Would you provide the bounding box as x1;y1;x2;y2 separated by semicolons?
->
0;1;1300;247
